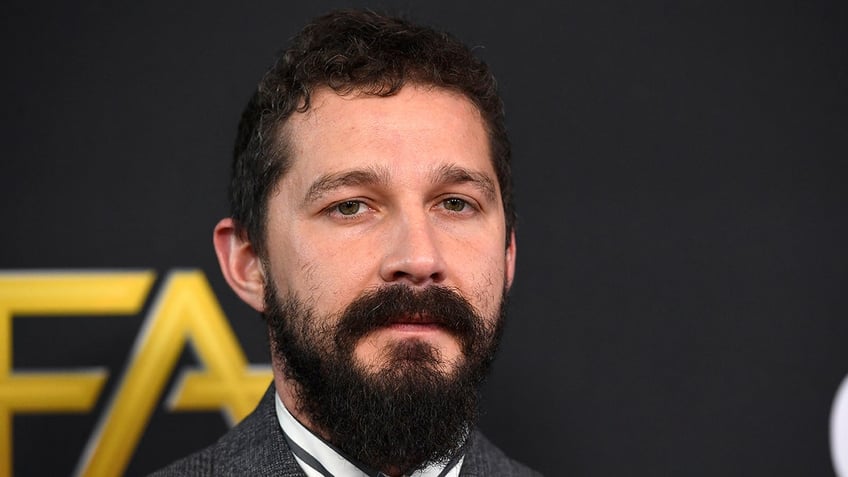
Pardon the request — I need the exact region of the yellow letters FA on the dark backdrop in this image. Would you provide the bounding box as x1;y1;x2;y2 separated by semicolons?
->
0;271;271;477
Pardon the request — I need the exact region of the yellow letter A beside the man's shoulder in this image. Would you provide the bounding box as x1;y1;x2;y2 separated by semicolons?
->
77;271;271;477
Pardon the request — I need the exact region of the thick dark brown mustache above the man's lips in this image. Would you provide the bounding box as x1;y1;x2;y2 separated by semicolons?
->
335;285;485;351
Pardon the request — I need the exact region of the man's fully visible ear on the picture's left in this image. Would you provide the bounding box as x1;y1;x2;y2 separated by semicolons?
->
212;218;265;312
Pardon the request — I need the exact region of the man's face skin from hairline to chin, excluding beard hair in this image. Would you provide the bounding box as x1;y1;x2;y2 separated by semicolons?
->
264;86;515;375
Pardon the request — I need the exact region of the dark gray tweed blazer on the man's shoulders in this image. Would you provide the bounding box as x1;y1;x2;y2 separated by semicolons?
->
151;385;541;477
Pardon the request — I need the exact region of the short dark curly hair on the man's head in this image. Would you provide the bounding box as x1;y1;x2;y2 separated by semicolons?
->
230;10;515;256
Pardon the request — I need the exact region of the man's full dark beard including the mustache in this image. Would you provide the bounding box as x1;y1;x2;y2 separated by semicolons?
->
264;285;506;474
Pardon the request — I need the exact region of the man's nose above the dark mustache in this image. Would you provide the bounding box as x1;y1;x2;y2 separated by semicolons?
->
380;214;445;287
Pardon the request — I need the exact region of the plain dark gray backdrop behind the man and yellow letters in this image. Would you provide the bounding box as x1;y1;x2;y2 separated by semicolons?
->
0;1;848;476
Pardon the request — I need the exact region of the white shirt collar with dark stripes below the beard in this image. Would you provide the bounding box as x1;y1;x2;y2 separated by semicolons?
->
274;393;465;477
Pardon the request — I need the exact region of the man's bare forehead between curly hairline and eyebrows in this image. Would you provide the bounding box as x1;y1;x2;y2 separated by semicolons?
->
283;85;494;181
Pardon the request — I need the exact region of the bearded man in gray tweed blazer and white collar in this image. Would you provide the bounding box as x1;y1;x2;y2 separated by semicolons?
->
152;11;537;477
